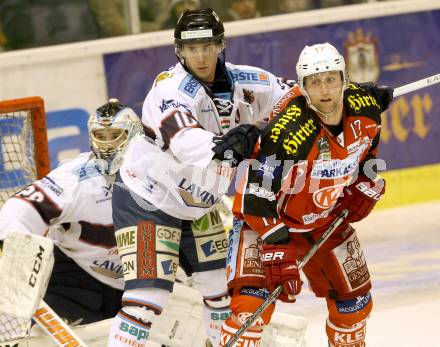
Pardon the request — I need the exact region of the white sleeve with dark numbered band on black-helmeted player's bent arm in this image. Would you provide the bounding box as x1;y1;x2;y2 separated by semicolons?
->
142;86;215;167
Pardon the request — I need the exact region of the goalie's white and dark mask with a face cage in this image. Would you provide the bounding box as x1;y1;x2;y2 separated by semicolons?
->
87;99;143;175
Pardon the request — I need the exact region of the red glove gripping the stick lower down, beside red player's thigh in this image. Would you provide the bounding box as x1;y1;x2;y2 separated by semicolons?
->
263;245;302;302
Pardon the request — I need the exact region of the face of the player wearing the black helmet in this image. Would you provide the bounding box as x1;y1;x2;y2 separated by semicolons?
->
180;42;220;83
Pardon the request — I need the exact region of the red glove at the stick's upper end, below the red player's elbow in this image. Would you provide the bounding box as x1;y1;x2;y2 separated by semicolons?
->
333;175;385;223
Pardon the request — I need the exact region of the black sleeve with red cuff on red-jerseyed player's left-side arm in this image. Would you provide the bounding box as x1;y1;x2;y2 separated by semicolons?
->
233;123;289;239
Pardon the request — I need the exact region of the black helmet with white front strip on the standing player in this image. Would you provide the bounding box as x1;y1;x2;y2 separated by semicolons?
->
174;8;225;48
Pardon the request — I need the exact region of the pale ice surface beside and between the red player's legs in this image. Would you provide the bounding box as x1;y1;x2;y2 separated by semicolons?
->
278;201;440;347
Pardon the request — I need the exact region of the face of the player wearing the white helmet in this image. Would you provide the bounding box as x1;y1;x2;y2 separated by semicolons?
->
304;71;343;113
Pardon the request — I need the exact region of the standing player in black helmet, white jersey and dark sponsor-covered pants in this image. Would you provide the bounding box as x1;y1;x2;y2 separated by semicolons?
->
109;9;296;347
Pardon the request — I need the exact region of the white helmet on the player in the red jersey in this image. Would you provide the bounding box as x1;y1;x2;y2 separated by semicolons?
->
296;42;348;93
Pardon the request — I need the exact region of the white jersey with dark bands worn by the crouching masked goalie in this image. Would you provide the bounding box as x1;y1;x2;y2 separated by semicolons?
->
0;152;124;289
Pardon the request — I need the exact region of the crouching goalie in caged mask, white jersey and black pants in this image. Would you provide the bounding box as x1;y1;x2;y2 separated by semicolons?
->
0;99;143;324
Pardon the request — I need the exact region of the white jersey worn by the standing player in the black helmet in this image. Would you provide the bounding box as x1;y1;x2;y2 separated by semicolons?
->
120;63;289;219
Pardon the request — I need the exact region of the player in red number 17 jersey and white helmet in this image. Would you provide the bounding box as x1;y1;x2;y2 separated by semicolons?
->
220;43;393;347
